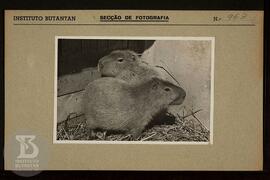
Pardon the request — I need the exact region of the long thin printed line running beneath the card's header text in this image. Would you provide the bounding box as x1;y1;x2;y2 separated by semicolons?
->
13;23;256;26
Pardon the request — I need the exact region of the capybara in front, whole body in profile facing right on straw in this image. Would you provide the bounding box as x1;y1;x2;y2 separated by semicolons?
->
83;77;186;138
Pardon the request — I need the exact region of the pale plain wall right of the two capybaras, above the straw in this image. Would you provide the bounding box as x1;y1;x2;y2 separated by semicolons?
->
142;40;211;129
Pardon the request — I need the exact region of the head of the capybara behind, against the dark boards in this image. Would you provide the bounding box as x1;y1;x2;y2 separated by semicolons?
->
98;50;140;77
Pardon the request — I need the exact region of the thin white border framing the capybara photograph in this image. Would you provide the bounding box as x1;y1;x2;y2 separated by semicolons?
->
53;36;215;145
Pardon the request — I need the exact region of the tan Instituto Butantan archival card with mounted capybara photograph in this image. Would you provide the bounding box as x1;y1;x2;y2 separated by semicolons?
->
4;10;264;171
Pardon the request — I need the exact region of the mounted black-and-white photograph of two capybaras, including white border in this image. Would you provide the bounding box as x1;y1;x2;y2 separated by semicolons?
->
54;36;215;144
